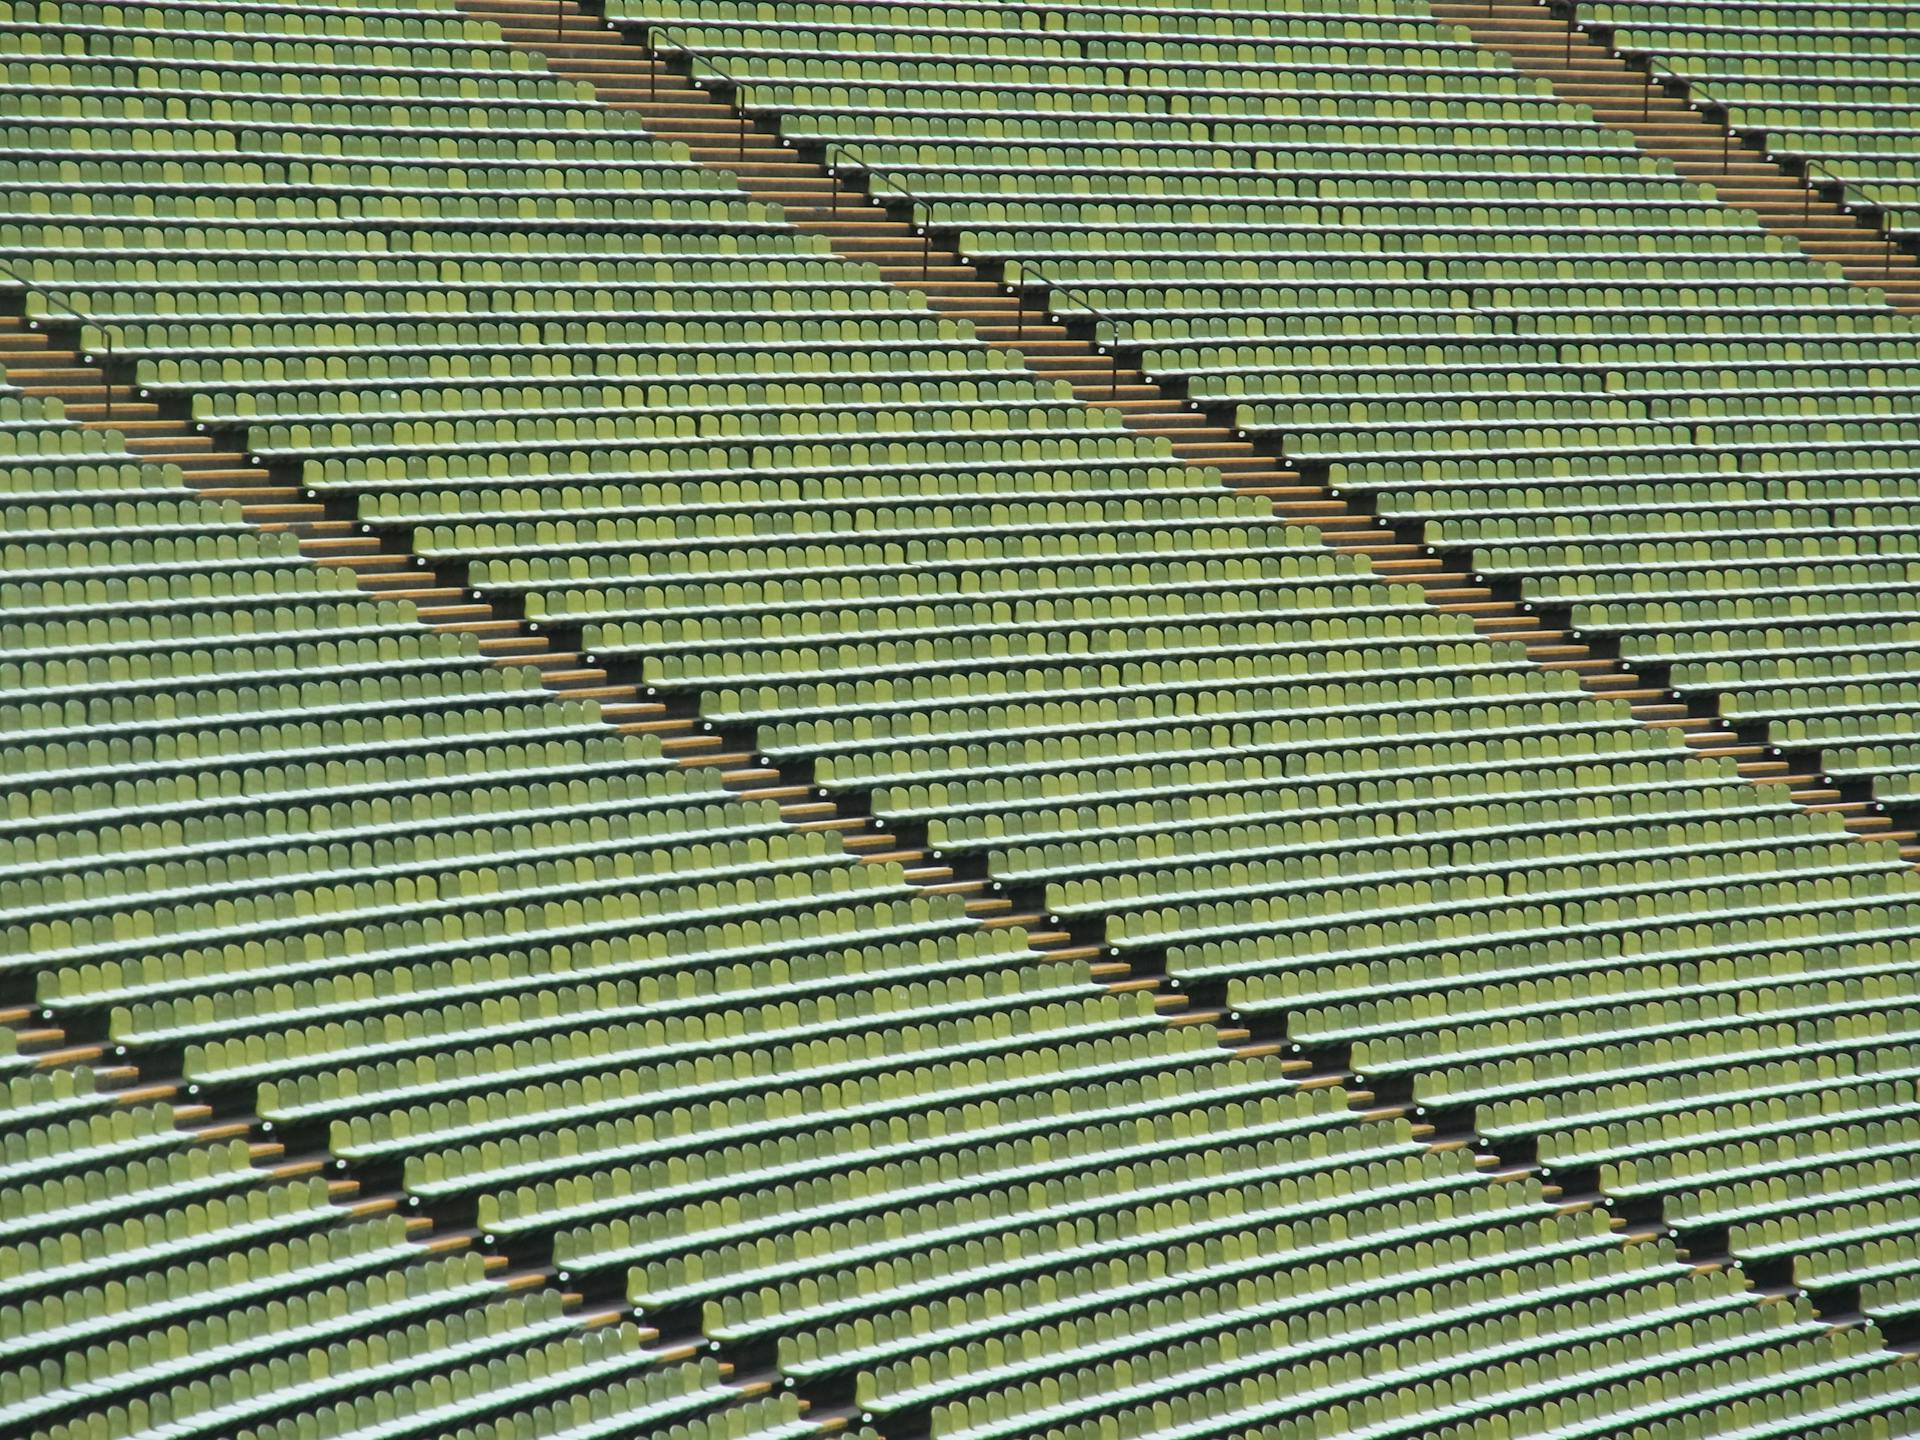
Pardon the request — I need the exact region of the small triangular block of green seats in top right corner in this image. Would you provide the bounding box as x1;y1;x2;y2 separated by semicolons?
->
1574;0;1920;242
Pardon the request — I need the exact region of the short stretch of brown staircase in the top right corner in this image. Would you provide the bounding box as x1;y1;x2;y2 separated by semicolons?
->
1432;0;1920;315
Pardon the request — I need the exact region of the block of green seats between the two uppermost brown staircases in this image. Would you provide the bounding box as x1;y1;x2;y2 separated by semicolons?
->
609;0;1912;814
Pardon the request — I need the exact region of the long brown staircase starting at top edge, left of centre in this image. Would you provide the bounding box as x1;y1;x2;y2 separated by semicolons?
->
459;0;1920;860
